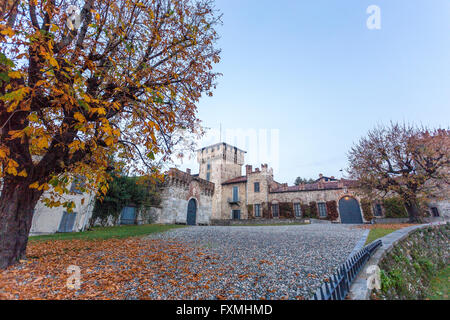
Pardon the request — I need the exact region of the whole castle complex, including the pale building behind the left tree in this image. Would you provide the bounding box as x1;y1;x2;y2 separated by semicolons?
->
30;143;450;235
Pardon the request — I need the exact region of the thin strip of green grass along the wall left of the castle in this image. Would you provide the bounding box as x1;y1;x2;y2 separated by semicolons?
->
29;224;185;241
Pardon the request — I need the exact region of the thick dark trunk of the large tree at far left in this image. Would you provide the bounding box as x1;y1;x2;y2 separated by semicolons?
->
0;181;42;269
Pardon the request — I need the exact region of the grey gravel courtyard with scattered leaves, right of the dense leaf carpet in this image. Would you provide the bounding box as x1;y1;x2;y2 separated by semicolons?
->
149;224;365;299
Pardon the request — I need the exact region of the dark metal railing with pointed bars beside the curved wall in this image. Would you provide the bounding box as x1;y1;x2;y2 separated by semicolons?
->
311;240;382;300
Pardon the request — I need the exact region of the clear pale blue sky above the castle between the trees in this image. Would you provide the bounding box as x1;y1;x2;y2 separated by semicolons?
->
175;0;450;184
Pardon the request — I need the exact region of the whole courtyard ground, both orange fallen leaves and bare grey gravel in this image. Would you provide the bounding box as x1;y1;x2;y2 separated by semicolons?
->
0;225;363;300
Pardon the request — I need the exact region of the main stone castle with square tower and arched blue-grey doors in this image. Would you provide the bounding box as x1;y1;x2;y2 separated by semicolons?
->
158;143;383;225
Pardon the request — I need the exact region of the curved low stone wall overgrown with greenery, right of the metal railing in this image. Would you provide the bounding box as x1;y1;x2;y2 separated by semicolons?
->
349;223;450;300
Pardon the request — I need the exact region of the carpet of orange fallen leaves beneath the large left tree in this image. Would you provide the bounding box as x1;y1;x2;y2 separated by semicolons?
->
0;239;218;299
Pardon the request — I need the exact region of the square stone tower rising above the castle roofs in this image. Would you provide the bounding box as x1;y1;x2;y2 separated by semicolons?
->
197;143;246;219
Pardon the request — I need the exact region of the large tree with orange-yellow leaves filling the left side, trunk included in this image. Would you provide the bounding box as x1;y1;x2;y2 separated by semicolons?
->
0;0;220;268
